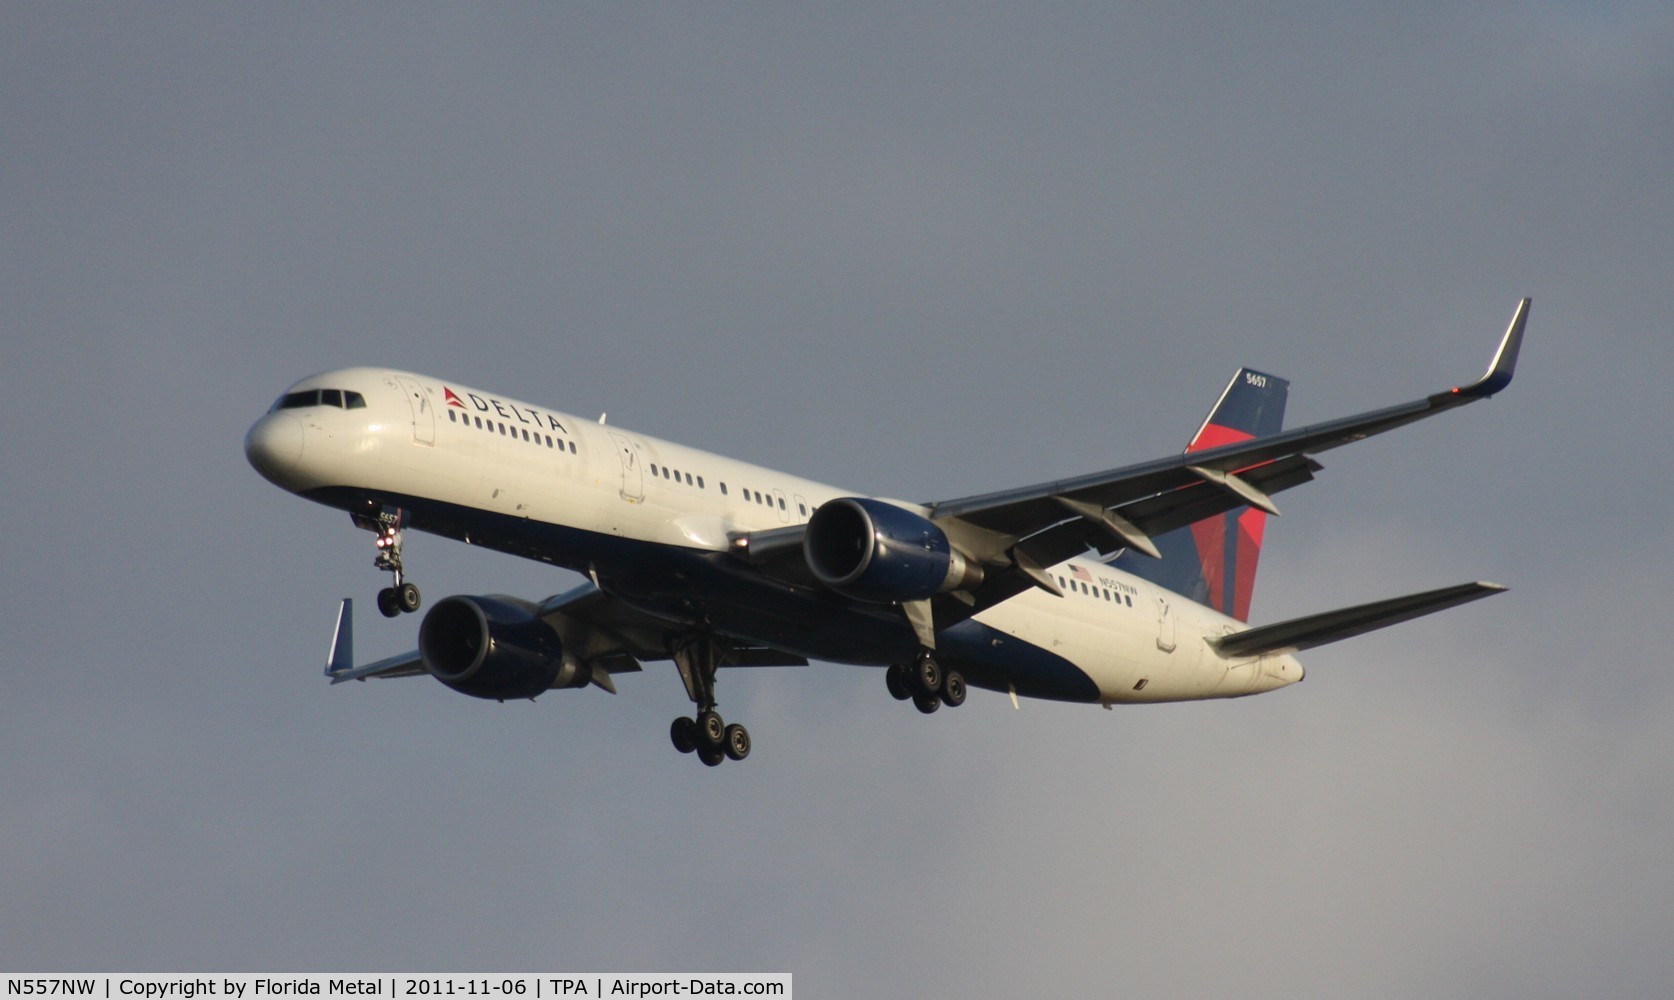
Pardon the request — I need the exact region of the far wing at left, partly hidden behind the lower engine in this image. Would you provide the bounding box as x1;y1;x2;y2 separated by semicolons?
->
325;583;807;693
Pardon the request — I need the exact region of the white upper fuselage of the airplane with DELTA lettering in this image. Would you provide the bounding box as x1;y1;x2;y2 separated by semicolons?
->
246;369;1302;707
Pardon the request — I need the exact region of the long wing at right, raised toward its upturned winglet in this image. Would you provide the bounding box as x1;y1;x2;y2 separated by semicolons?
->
927;298;1530;576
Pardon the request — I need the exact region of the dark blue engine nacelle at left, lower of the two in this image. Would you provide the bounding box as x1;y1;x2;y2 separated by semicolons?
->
419;596;593;702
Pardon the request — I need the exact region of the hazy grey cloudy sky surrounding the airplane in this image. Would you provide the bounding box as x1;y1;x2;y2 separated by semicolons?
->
0;3;1674;998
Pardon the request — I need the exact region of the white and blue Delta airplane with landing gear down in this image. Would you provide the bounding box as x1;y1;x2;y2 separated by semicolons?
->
244;298;1530;767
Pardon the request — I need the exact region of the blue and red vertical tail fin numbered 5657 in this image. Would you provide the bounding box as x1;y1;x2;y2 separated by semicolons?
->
1117;369;1291;621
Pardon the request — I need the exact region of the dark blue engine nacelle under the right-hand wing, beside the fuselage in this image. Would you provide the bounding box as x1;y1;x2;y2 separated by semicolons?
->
802;496;983;605
